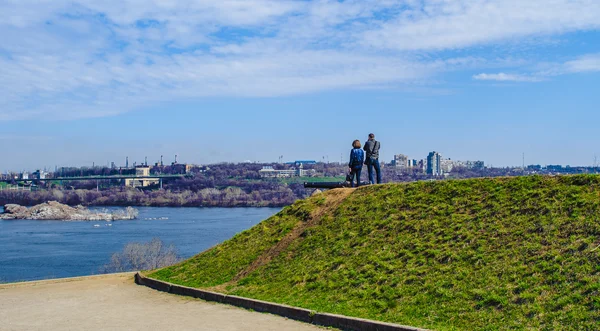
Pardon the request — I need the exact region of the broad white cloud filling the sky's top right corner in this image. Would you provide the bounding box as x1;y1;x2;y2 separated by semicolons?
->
362;0;600;50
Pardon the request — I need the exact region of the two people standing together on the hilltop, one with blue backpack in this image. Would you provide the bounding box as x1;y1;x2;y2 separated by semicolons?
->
348;133;381;187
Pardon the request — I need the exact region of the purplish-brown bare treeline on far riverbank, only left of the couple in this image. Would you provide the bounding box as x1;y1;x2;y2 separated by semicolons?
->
0;164;328;207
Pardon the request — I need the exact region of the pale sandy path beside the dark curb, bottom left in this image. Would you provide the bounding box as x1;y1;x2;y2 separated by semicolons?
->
0;273;323;331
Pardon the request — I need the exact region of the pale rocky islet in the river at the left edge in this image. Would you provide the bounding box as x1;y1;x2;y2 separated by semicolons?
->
0;201;138;221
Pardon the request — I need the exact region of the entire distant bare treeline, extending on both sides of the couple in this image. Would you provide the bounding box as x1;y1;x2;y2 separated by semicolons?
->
0;163;564;207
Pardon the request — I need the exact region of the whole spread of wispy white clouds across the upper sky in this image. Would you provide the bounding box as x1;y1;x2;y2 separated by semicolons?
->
0;0;600;120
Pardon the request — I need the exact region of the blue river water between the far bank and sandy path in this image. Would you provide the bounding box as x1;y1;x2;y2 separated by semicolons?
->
0;207;280;282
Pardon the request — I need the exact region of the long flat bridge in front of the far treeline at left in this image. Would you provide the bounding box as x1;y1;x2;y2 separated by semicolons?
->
0;175;189;190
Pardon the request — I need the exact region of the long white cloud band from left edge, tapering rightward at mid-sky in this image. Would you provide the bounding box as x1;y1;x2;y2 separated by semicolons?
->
0;51;439;120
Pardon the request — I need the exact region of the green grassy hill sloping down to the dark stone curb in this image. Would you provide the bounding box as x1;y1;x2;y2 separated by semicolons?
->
149;175;600;330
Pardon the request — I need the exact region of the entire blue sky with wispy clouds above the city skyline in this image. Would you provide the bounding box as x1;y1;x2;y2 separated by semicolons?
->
0;0;600;172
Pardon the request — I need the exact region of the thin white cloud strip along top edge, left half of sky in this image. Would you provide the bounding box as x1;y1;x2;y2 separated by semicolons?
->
0;0;304;27
